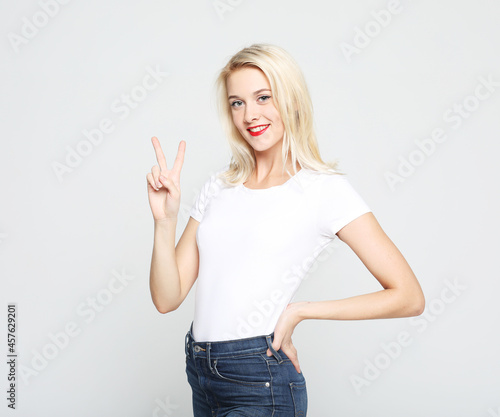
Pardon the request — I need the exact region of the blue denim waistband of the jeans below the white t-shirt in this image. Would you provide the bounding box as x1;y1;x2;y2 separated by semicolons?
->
184;322;283;363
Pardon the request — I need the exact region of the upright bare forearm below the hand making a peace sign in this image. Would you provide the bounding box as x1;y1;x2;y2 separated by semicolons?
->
149;220;181;313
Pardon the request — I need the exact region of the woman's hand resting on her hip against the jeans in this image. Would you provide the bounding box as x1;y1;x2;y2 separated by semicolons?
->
267;302;304;373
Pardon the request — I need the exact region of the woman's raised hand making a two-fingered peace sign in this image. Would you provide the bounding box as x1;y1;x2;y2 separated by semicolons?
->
146;136;186;222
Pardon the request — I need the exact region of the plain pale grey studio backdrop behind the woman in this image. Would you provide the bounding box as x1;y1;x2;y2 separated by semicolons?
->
0;0;500;417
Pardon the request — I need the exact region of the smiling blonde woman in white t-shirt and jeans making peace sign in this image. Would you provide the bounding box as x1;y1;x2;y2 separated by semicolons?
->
147;44;425;417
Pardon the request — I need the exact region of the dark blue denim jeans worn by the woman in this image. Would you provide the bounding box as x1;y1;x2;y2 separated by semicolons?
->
185;323;307;417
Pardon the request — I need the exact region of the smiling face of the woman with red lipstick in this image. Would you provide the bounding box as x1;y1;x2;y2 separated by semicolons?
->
227;67;285;152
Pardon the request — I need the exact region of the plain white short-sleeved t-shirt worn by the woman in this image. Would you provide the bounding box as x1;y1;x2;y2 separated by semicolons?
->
190;165;371;342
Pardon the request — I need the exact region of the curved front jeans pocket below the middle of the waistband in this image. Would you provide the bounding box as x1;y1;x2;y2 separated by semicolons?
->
212;354;271;387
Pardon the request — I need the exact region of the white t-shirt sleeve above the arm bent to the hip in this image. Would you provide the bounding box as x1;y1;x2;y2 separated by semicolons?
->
318;174;371;239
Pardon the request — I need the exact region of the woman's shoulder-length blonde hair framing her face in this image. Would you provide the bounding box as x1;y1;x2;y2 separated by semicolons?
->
215;43;344;185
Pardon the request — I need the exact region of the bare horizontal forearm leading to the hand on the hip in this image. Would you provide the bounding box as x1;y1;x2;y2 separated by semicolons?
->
297;288;423;320
